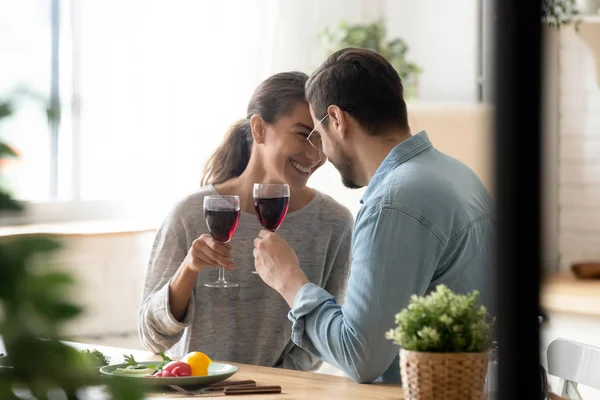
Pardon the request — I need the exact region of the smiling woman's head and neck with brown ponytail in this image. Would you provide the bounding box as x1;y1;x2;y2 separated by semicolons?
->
202;72;325;189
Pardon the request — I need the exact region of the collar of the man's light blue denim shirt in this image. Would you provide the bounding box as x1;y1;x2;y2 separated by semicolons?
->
360;131;433;204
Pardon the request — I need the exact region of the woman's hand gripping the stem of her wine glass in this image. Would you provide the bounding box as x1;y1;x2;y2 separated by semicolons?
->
182;233;234;273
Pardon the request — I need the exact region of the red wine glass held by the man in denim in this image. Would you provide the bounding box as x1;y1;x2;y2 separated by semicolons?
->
252;183;290;274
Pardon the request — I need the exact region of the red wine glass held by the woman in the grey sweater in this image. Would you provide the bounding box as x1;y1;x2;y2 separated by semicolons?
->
204;196;240;288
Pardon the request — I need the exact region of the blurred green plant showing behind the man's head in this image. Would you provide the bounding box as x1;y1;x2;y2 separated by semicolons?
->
321;20;421;100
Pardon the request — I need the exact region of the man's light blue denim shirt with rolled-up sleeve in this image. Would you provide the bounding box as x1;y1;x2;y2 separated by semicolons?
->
289;132;495;383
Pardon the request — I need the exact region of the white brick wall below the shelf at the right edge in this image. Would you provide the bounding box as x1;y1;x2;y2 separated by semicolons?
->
558;25;600;271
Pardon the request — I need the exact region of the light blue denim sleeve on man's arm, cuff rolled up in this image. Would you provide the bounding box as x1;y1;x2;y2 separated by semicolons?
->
289;207;442;383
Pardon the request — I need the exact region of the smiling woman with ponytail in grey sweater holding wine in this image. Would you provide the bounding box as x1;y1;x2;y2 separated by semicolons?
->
139;72;353;370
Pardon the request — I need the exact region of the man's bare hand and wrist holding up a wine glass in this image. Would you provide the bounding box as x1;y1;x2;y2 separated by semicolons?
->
253;230;309;308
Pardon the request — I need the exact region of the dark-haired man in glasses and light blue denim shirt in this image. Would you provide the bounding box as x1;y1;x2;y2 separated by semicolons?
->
254;48;495;383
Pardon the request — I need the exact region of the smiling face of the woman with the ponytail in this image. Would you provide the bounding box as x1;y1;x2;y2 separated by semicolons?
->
255;101;325;189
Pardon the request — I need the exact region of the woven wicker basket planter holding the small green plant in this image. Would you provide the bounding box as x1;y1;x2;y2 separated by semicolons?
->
400;349;489;400
